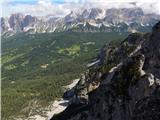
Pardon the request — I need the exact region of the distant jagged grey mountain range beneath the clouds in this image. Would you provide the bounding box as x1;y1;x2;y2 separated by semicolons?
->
0;8;160;36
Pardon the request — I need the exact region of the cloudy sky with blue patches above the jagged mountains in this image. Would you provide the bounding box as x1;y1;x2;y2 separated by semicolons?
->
0;0;160;16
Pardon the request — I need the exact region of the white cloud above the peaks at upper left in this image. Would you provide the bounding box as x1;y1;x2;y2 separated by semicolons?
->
2;0;70;16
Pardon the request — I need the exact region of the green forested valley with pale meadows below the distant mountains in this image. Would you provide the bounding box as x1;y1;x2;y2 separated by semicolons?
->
1;33;126;120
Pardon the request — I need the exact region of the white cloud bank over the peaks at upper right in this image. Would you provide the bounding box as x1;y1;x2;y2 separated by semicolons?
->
86;0;160;14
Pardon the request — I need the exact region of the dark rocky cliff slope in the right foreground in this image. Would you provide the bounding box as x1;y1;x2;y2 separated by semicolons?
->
52;22;160;120
